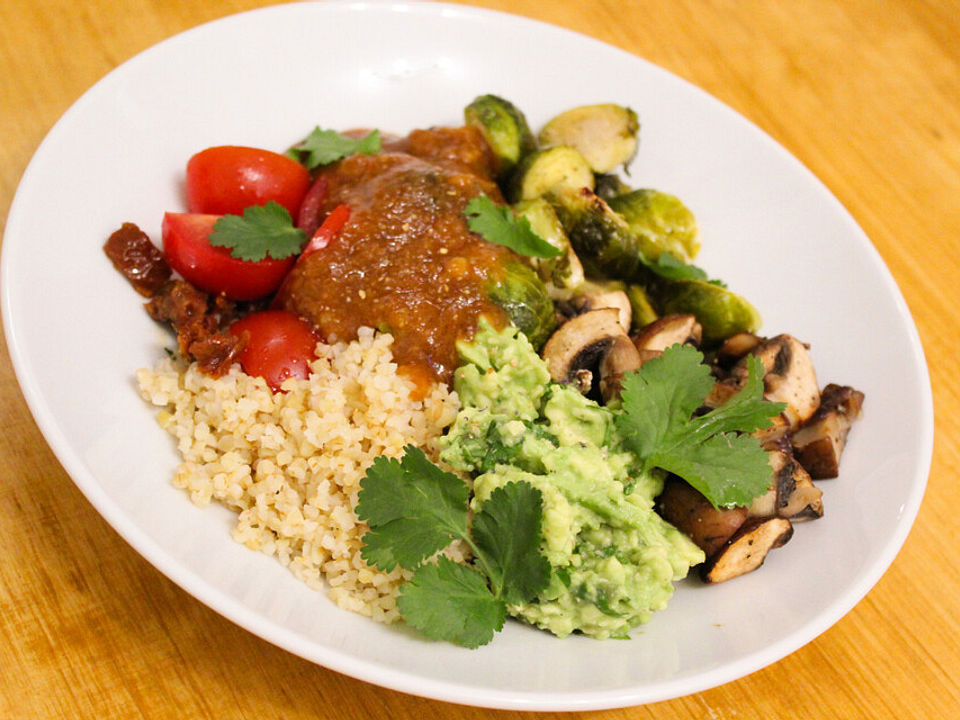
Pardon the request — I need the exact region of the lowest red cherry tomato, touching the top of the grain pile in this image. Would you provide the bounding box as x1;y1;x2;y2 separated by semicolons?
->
230;310;320;392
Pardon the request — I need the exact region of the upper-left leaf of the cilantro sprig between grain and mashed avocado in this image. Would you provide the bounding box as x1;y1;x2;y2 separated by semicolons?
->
356;445;469;572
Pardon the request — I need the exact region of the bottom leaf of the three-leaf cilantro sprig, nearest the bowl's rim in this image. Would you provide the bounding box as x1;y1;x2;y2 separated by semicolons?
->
397;556;507;648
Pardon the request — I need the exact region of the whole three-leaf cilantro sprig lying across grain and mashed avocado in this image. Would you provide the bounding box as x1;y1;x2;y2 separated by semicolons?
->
356;445;550;648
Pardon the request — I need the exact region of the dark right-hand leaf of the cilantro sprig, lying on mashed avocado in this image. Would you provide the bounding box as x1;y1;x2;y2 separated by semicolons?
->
473;482;550;605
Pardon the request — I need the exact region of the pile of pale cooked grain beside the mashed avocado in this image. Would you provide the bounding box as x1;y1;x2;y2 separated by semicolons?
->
137;329;458;622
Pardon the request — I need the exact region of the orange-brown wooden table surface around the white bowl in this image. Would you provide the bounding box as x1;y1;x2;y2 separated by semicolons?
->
0;0;960;720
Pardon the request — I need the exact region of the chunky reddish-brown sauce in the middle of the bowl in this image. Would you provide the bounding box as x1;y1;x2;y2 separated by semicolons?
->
278;128;513;386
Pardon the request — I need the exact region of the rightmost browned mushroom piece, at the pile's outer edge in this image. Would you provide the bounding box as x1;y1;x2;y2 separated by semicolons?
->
791;383;863;480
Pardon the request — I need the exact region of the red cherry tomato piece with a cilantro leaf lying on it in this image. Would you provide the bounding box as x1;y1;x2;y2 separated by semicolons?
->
162;213;296;300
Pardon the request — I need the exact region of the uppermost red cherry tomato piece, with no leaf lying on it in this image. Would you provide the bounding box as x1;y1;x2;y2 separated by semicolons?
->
187;145;310;218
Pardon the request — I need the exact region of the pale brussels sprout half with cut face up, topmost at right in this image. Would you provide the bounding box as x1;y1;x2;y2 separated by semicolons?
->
537;103;640;173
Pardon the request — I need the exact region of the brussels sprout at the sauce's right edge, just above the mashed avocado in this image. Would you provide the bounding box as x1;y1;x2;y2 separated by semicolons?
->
487;261;557;350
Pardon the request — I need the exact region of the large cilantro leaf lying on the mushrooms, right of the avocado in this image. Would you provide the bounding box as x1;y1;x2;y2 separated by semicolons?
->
617;345;785;507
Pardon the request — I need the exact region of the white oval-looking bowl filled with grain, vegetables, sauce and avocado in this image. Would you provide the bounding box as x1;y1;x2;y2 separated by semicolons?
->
2;3;932;709
